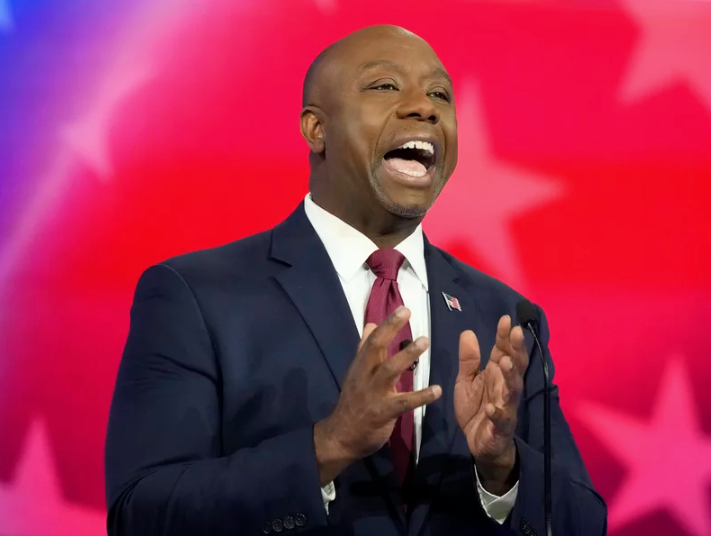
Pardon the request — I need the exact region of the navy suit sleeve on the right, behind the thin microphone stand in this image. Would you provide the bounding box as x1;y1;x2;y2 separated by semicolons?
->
511;311;607;536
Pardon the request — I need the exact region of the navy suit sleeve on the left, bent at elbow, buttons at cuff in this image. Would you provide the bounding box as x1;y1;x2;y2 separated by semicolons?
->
105;265;327;536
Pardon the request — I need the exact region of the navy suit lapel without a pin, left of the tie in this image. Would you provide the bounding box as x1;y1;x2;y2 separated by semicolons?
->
272;203;359;391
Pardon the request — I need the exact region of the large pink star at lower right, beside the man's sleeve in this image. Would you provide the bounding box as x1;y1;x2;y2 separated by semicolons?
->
579;356;711;536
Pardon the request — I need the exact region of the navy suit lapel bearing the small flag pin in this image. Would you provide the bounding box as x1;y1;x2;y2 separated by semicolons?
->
409;241;480;534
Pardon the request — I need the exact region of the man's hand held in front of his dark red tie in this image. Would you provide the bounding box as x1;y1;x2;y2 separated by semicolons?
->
314;307;442;486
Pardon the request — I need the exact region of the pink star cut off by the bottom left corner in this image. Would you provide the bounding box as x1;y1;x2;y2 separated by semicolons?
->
0;422;106;536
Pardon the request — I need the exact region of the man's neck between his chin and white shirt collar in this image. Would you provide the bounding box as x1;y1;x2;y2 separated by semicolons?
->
311;189;422;249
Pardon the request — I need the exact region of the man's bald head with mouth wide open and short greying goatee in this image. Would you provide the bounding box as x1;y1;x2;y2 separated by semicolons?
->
301;22;457;234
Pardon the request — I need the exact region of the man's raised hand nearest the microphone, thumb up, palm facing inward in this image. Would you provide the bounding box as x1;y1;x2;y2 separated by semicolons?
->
454;315;528;495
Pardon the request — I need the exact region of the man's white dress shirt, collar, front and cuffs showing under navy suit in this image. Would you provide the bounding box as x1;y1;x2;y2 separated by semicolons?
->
304;194;518;523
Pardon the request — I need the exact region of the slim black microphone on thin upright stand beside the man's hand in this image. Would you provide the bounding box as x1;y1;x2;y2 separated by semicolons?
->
516;299;553;536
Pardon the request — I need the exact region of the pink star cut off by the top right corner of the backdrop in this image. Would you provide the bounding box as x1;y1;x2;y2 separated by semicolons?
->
621;0;711;110
